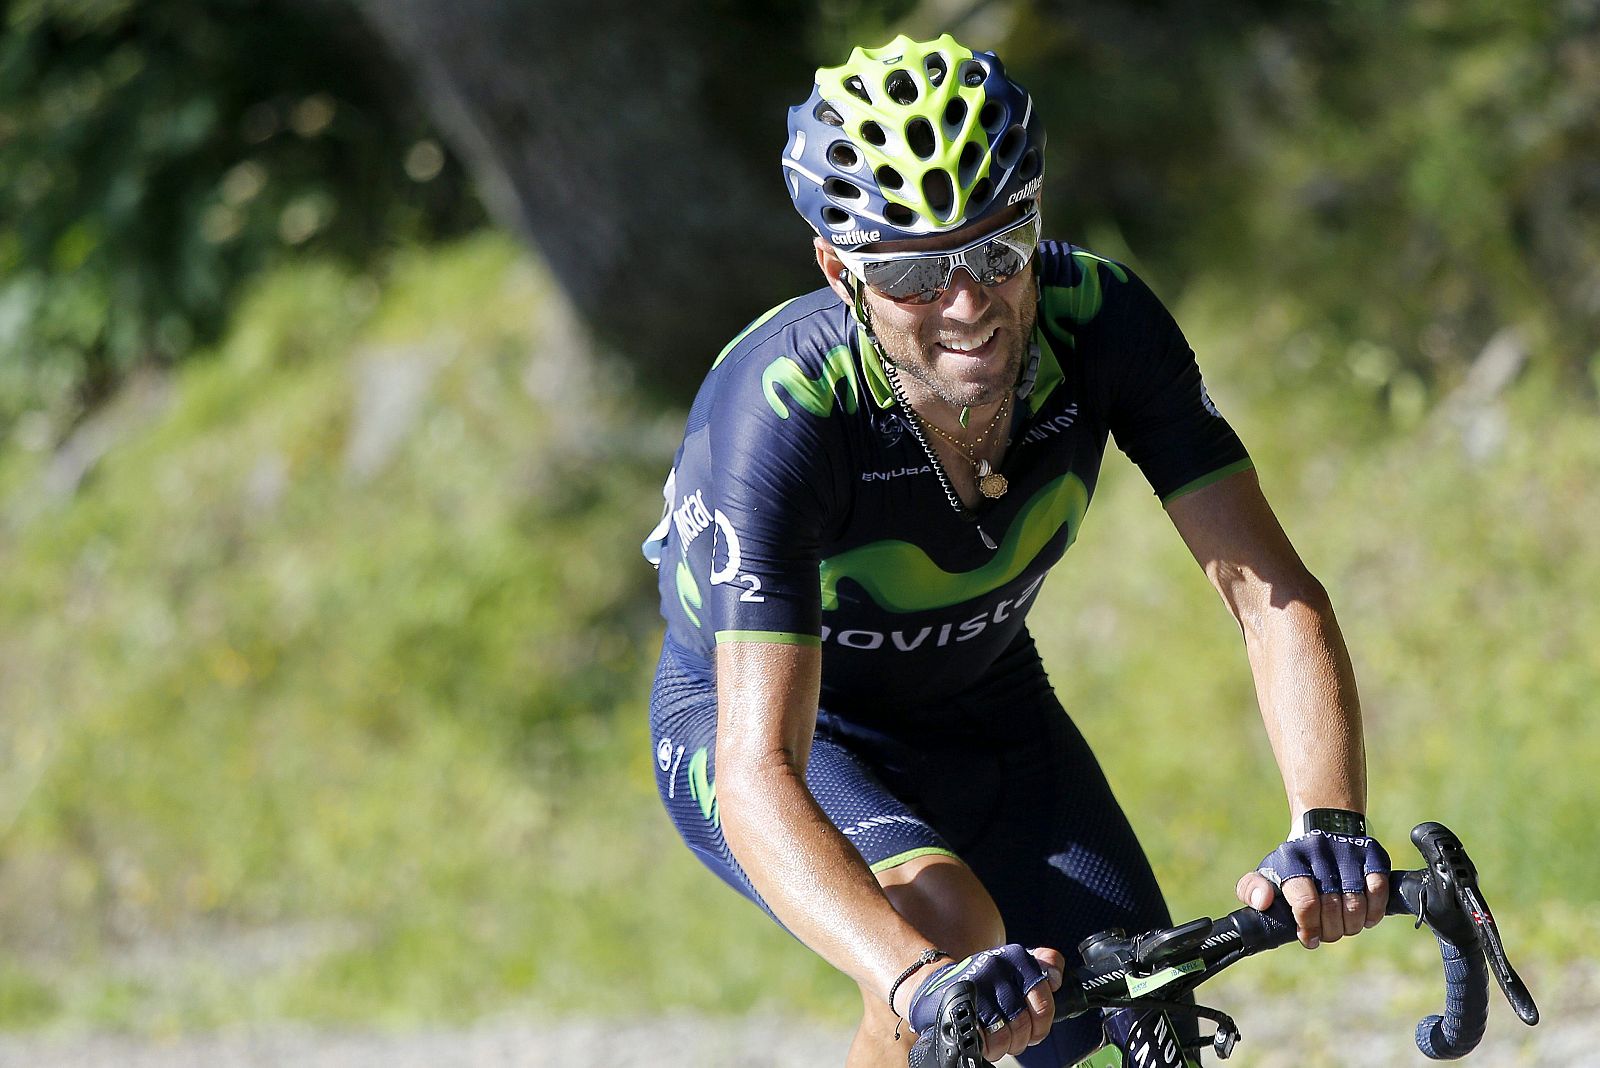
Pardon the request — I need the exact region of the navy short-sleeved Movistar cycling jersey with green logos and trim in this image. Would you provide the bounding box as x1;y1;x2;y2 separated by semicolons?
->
645;241;1250;716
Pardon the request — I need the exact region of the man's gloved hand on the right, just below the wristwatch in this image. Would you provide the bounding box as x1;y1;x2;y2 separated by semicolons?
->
1235;831;1389;950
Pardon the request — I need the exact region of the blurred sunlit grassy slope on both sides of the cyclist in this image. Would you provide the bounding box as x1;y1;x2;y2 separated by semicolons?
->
0;237;1600;1033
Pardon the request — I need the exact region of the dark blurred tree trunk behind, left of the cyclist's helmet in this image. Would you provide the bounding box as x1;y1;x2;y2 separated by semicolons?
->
357;0;819;398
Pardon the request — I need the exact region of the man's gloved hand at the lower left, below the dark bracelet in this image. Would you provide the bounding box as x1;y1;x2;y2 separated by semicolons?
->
906;945;1067;1062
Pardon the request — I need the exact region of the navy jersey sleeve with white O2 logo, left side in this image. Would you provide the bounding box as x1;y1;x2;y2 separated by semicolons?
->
704;349;859;644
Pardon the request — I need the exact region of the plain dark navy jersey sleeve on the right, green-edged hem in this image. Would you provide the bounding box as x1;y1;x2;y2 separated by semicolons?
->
1085;261;1251;502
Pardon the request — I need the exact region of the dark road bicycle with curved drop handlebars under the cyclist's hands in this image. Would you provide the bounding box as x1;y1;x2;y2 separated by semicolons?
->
910;823;1539;1068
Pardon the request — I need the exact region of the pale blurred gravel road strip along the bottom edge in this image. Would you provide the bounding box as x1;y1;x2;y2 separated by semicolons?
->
0;967;1600;1068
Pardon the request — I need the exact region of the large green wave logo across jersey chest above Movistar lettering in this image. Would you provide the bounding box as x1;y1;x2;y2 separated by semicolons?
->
821;475;1090;612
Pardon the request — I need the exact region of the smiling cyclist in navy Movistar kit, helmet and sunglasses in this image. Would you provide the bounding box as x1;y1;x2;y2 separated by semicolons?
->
645;35;1389;1068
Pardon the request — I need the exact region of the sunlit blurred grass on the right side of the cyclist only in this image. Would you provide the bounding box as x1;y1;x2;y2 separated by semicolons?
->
1030;278;1600;1012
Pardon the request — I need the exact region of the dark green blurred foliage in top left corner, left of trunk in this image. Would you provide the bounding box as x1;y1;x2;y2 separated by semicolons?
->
0;0;483;435
